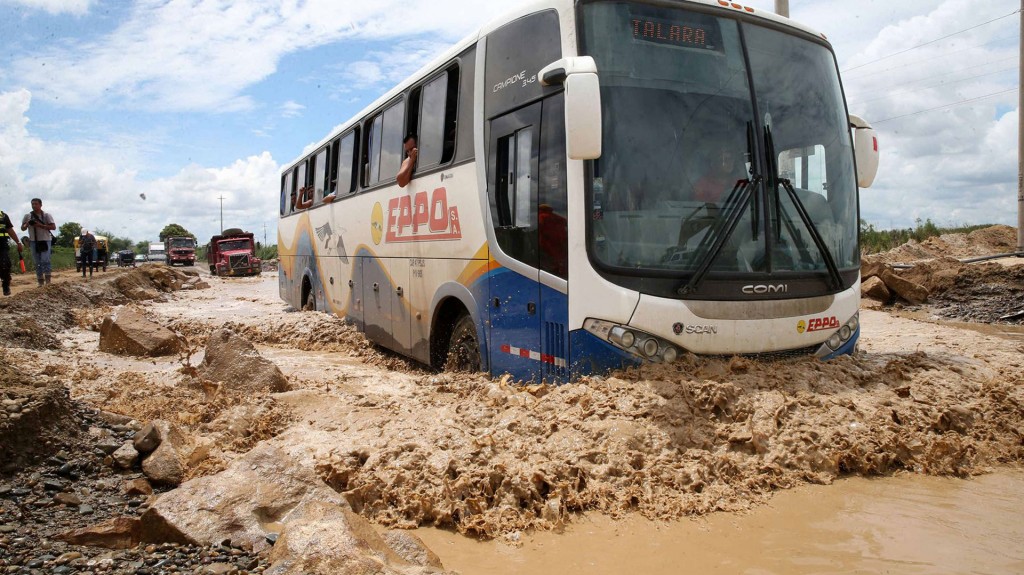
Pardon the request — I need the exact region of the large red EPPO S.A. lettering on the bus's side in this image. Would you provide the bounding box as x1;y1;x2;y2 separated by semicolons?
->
384;187;462;244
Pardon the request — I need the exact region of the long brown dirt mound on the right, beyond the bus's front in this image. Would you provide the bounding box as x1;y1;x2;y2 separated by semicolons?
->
864;225;1017;264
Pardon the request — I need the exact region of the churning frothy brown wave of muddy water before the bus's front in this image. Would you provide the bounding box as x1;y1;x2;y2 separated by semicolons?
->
316;353;1024;537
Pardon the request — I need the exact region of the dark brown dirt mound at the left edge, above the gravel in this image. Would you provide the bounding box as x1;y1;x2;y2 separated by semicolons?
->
0;350;79;474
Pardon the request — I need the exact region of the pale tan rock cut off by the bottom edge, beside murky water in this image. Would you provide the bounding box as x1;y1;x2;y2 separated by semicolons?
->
265;501;424;575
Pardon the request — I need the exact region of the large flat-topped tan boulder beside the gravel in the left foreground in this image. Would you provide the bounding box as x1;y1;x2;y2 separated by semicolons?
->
142;445;347;551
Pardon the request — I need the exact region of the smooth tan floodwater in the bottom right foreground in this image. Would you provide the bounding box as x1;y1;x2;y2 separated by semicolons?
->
416;470;1024;575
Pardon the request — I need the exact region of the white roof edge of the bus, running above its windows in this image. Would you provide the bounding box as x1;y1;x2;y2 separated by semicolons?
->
282;0;828;169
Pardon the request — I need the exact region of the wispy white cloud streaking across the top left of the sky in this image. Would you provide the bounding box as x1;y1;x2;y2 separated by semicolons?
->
11;0;514;112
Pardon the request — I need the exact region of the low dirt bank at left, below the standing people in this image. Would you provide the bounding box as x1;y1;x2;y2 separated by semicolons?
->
0;266;196;349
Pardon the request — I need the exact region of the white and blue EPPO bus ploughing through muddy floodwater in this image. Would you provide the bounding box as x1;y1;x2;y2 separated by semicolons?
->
278;0;879;383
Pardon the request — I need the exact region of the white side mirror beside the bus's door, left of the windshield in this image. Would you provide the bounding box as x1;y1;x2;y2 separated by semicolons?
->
538;56;601;160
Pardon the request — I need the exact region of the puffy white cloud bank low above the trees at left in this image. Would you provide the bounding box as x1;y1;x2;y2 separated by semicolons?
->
0;90;280;241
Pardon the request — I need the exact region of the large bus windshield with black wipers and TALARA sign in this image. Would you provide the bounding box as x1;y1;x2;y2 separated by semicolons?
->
582;1;859;277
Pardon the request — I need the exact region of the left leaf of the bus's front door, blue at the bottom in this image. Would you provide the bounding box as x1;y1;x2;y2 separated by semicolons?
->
487;102;542;381
